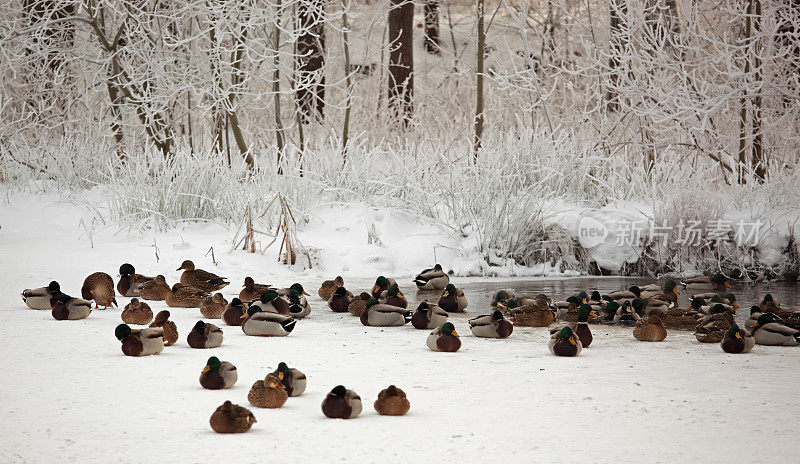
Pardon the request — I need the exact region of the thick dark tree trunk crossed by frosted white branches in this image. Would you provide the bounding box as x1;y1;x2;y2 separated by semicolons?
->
295;0;325;123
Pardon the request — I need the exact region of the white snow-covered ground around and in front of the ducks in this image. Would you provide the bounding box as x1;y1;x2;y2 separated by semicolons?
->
0;190;800;463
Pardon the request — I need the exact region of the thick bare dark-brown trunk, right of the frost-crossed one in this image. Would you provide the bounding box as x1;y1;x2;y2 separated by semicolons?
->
388;0;414;125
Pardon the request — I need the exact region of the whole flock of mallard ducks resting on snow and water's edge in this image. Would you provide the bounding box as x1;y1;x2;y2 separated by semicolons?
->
22;260;800;433
